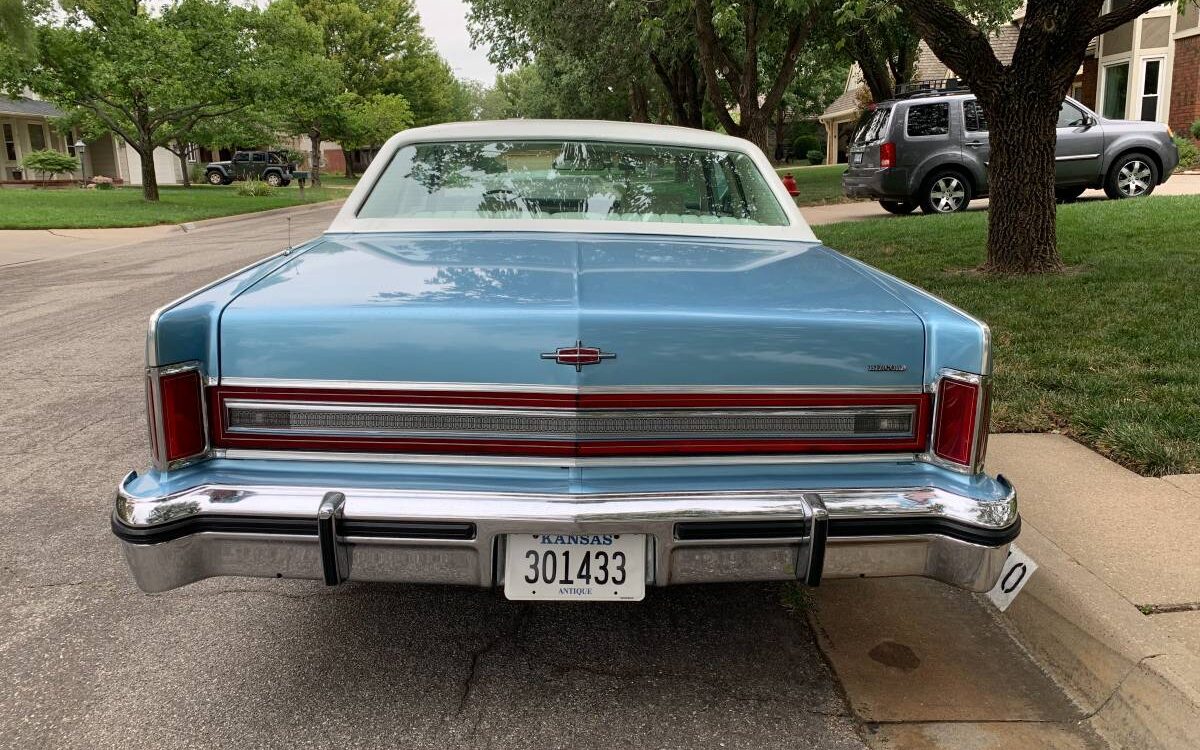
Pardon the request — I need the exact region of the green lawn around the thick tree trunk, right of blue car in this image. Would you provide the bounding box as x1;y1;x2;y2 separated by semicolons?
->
817;197;1200;475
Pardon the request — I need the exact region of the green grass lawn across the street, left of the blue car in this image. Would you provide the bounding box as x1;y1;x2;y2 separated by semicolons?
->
0;184;348;229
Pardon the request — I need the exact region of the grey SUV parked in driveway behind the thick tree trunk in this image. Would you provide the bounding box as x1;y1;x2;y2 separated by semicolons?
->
841;92;1180;214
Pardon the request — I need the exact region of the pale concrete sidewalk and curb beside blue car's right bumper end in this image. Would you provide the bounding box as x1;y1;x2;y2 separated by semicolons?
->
988;434;1200;748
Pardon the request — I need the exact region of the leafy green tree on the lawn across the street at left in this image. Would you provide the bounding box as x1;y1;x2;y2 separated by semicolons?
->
28;0;254;200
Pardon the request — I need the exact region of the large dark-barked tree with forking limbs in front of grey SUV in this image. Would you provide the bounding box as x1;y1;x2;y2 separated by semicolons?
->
888;0;1194;274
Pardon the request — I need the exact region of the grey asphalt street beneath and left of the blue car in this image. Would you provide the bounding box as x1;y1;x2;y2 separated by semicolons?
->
0;209;863;749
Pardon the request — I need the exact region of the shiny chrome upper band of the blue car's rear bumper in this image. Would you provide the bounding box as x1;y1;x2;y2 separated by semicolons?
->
116;474;1018;530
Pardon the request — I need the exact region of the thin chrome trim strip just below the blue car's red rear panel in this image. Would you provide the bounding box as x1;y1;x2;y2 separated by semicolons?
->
214;448;917;467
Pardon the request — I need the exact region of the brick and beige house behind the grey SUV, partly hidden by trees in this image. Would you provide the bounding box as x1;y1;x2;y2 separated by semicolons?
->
821;0;1200;164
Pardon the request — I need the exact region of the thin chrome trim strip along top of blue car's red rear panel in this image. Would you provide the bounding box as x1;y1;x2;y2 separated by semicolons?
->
220;378;925;396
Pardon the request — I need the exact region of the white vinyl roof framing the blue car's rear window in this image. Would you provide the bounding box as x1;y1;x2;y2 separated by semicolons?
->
326;120;816;242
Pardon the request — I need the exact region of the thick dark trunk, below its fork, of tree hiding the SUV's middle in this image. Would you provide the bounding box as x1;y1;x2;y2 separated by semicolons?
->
984;91;1062;274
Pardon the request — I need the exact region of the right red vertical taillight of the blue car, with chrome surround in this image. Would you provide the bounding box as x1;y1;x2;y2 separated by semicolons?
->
932;373;991;472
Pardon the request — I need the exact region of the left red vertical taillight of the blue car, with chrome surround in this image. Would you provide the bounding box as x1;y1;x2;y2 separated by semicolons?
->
146;364;209;469
